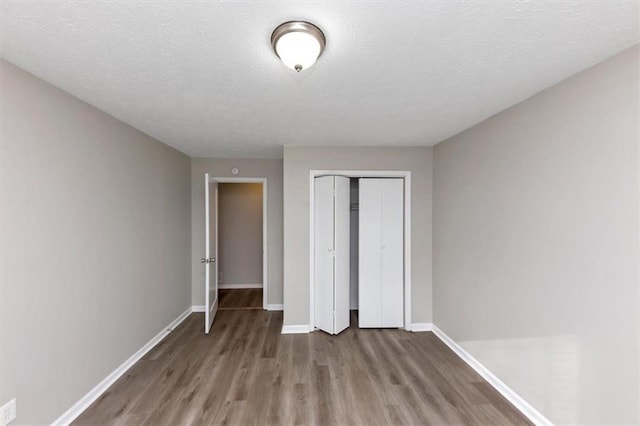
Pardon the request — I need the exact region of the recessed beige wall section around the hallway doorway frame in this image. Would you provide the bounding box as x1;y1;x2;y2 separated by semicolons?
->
191;158;282;305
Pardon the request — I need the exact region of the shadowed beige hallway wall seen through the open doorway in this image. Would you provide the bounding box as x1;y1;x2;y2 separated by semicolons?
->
218;183;262;285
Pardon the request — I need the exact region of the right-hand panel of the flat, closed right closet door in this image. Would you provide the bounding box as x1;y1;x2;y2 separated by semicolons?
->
380;179;404;327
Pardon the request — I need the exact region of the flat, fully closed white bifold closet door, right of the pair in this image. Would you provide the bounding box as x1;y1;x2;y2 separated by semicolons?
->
358;178;404;328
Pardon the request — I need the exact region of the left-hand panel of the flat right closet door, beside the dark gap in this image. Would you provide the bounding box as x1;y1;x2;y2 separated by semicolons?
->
358;179;382;328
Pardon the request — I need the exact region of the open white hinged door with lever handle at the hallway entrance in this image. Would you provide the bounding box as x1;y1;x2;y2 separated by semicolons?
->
201;173;218;334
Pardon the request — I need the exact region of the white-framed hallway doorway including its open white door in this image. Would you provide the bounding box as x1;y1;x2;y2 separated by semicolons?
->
202;174;268;333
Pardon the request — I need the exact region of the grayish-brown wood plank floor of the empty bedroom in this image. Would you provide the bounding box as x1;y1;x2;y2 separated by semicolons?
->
74;310;530;425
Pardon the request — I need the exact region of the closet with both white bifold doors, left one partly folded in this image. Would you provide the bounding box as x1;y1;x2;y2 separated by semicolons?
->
313;176;404;334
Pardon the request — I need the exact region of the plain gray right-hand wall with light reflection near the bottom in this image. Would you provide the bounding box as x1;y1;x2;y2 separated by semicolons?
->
433;46;640;424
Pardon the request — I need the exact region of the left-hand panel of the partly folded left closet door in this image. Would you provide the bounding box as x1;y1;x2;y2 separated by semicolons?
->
313;176;335;334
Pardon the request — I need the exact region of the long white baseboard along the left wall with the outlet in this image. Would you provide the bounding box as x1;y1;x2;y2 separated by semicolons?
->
52;307;192;426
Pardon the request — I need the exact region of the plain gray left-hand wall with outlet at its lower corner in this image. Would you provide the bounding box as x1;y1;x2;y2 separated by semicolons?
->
0;62;191;424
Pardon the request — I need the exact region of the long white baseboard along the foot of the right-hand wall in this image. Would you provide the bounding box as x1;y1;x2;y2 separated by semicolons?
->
432;325;553;426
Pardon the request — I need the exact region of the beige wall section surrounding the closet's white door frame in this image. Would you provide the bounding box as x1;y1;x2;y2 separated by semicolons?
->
284;146;433;325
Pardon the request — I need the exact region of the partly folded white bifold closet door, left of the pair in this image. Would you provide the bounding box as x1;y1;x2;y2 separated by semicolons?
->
313;176;351;334
